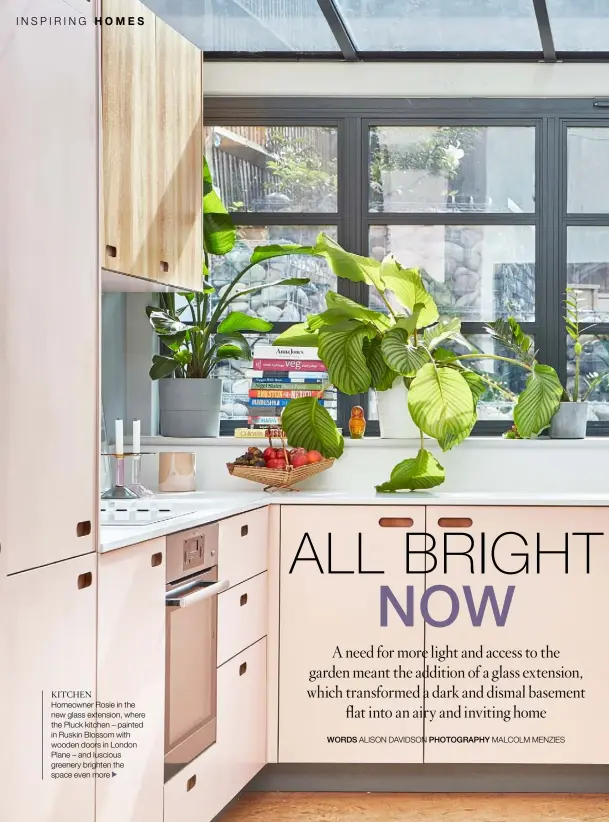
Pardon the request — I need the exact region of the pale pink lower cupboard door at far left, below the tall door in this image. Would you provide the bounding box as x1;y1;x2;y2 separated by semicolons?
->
2;556;97;822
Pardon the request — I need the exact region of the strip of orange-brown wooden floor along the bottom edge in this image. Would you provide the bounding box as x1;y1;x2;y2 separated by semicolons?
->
221;793;609;822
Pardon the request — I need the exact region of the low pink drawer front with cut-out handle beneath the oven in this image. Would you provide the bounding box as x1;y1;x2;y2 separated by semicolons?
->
164;743;223;822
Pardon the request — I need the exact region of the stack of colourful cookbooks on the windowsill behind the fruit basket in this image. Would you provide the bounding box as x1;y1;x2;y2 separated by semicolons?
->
247;345;337;426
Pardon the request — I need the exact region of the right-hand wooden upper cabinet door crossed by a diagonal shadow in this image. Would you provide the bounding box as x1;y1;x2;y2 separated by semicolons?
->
156;18;203;291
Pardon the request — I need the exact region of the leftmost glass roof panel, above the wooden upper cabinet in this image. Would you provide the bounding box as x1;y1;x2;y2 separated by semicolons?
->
145;0;340;53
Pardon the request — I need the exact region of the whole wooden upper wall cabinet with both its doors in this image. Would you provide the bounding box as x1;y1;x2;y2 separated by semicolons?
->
101;0;203;290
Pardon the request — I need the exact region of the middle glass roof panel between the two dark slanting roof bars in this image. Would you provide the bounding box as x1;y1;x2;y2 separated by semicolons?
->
338;0;541;51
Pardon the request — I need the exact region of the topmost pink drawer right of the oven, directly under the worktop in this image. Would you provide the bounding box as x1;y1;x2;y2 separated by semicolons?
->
218;508;269;586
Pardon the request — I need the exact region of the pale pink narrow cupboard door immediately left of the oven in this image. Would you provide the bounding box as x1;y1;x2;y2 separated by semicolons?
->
96;538;165;822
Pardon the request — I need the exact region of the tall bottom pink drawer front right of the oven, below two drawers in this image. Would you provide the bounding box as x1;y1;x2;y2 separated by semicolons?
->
218;639;266;799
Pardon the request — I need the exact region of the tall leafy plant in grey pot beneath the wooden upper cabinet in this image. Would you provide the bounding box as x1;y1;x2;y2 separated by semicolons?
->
146;162;309;444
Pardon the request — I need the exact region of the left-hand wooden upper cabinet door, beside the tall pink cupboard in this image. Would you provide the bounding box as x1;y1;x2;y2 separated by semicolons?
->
101;0;161;280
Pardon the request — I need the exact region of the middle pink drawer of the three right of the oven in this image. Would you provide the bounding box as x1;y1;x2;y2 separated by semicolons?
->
218;571;268;665
